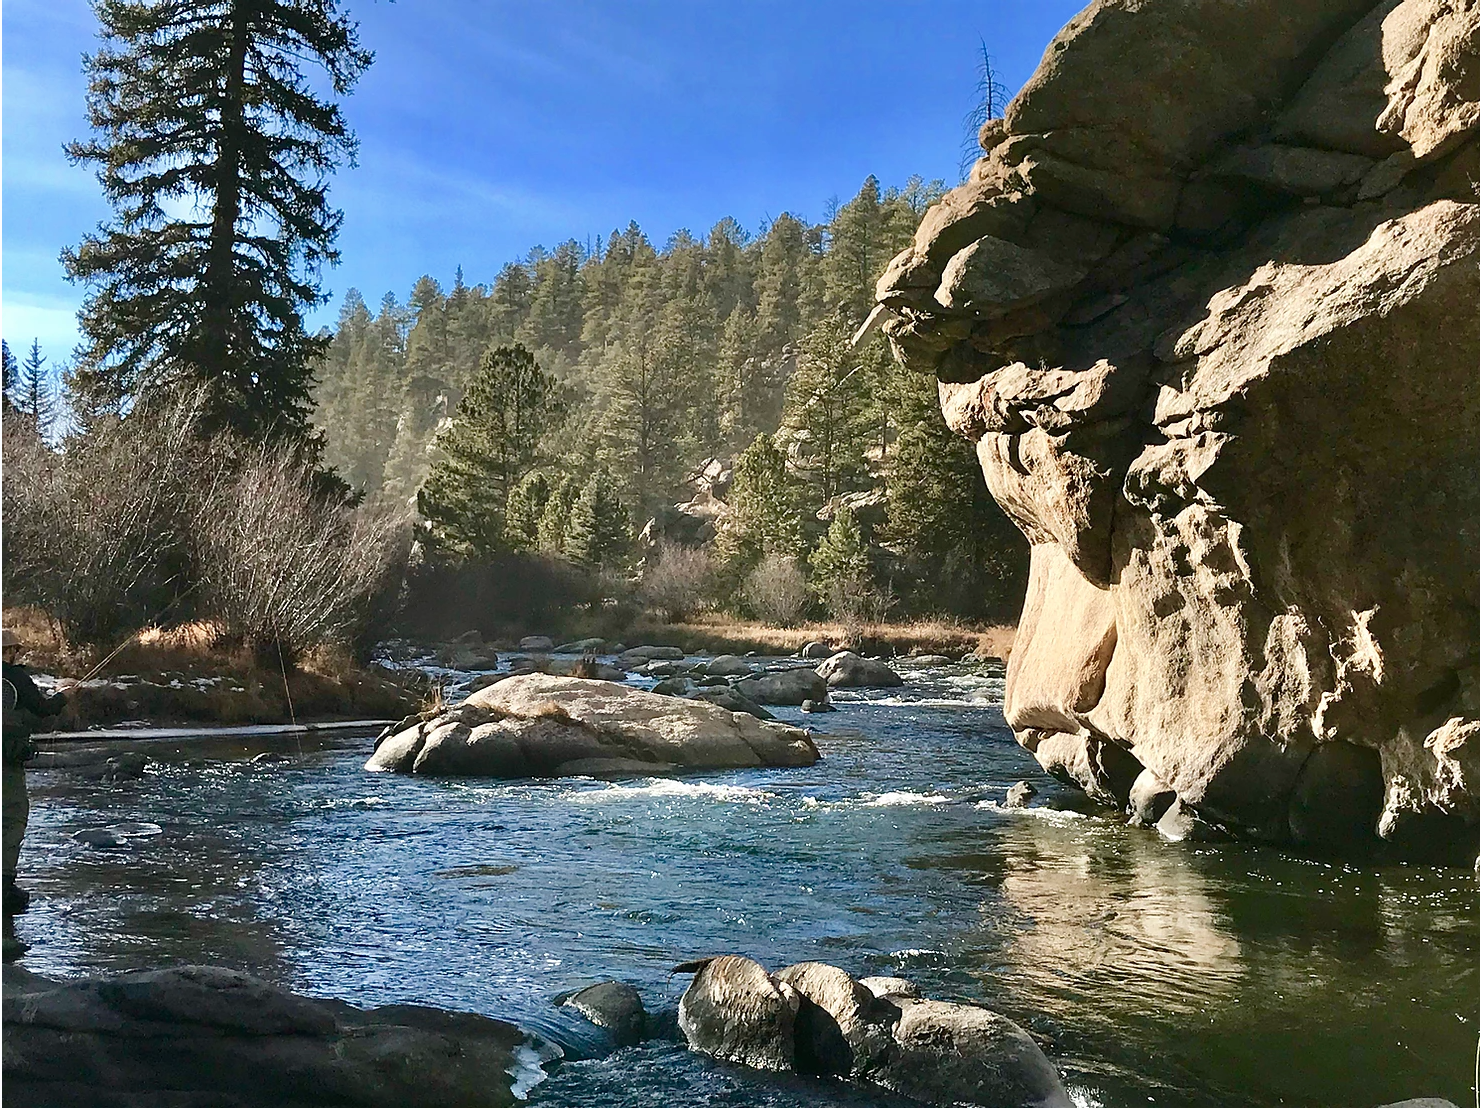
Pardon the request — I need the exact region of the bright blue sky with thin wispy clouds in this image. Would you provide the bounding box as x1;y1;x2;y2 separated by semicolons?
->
0;0;1079;371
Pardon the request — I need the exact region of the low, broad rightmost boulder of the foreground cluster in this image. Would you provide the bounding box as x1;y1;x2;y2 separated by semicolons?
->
876;1000;1073;1108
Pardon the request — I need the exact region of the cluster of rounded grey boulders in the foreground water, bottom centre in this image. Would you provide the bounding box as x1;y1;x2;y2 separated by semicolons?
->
675;954;1072;1108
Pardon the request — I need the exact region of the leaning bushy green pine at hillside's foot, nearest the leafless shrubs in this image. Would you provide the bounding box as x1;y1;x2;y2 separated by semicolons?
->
417;346;561;556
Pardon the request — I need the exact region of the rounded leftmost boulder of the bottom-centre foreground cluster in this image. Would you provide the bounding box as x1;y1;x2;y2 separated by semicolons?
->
678;954;801;1070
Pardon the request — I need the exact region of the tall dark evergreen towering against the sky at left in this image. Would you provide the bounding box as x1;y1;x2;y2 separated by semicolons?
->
64;0;371;438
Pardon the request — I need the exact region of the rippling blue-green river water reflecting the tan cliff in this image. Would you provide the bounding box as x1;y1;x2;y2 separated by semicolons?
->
18;667;1480;1108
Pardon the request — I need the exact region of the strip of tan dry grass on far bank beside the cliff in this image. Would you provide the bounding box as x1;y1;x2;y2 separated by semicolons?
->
625;617;1017;658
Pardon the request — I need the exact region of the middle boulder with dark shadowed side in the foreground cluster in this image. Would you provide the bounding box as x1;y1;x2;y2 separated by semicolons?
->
776;962;894;1077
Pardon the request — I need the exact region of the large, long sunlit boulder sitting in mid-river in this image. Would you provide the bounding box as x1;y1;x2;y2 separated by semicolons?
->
366;673;818;778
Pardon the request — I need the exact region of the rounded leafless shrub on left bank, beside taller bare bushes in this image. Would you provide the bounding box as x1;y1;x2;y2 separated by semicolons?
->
194;448;408;660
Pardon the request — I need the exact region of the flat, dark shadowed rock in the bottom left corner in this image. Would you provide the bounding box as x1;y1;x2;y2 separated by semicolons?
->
4;966;534;1108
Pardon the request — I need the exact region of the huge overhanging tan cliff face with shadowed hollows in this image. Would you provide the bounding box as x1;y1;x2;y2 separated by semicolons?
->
876;0;1480;862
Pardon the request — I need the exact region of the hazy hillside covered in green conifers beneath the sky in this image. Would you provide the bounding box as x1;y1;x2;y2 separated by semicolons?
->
314;178;1024;615
